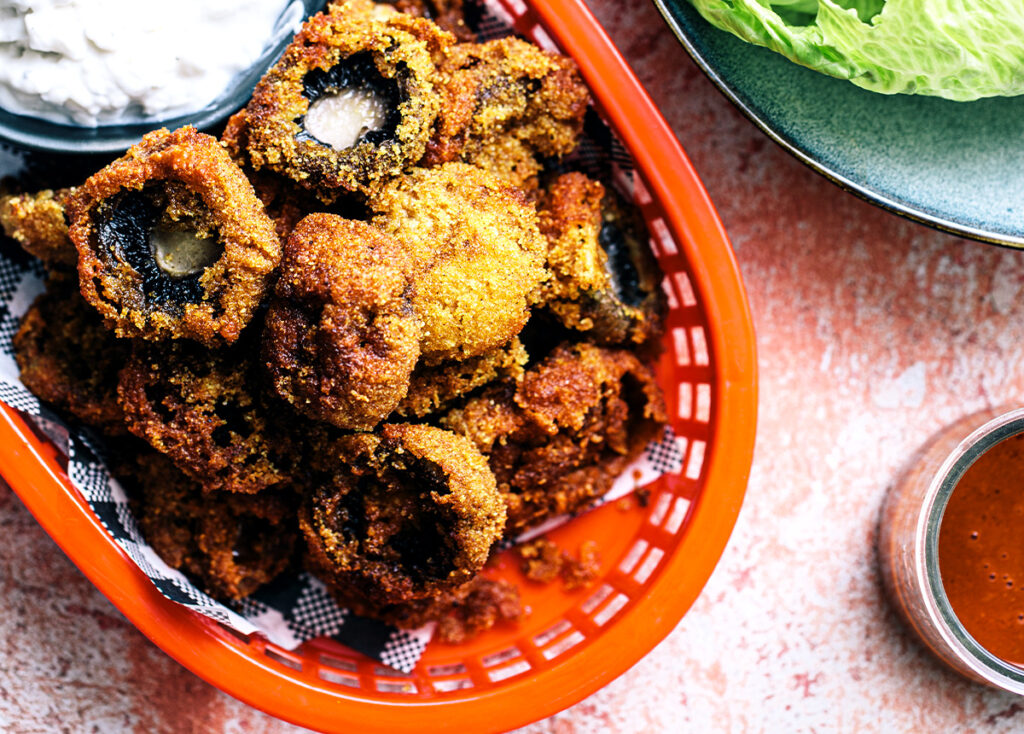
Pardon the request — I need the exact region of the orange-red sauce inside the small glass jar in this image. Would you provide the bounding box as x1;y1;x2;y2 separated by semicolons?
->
939;434;1024;666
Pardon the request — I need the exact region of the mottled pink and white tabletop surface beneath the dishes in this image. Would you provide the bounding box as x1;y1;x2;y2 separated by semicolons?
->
0;0;1024;734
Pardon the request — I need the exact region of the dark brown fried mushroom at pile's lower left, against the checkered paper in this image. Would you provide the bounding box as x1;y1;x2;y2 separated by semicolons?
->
113;451;298;599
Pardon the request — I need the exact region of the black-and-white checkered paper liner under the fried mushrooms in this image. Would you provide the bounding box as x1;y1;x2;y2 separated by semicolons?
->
0;3;685;673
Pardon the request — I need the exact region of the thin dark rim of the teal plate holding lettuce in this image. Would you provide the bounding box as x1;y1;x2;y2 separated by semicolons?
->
651;0;1024;250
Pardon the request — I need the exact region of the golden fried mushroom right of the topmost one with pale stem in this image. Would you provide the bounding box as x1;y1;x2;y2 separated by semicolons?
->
422;37;590;165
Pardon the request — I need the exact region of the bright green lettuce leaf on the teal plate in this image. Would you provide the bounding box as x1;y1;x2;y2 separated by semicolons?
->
690;0;1024;101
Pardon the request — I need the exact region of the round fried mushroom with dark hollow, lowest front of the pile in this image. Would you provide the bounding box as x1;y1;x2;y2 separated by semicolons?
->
300;424;505;606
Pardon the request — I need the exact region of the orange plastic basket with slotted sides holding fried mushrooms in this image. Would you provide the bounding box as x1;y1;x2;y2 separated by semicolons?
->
0;0;757;732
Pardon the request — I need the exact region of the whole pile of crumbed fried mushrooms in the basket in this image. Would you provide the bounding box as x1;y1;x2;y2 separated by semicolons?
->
0;0;666;641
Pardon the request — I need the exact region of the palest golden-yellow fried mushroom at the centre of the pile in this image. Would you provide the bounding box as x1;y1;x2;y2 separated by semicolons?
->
372;163;547;364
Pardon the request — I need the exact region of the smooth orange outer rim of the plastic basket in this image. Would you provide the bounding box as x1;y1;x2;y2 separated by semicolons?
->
0;0;757;732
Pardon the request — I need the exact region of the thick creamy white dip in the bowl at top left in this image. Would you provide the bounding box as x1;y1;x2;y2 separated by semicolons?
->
0;0;302;126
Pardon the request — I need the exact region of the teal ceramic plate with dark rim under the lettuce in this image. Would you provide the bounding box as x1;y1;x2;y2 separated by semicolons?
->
654;0;1024;248
